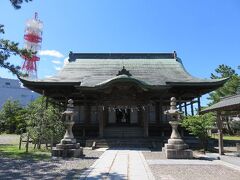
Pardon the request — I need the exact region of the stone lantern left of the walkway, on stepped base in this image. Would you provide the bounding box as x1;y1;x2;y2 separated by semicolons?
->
52;99;83;157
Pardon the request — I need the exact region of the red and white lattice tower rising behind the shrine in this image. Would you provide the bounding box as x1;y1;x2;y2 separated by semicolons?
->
22;13;43;79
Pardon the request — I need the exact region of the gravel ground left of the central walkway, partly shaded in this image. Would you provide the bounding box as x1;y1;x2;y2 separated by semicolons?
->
0;149;103;180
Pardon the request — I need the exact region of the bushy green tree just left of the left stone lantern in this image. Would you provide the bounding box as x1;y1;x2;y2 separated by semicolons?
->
25;97;65;148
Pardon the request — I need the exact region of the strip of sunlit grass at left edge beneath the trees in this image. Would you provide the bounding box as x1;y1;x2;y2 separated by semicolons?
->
0;144;51;161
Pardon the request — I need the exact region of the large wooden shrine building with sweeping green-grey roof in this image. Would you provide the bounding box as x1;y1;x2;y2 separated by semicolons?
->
20;52;227;137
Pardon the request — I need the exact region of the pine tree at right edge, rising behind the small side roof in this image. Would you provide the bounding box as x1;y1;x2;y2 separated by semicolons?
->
208;64;240;105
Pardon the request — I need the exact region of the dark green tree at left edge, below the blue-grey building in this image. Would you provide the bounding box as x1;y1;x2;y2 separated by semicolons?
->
0;100;25;133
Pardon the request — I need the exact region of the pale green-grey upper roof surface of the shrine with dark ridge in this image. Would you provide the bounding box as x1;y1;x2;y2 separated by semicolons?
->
38;53;225;87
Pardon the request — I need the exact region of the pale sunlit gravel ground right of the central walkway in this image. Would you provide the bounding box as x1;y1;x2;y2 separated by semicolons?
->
143;152;240;180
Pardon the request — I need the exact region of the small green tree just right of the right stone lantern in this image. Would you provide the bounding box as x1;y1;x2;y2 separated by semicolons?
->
181;113;215;152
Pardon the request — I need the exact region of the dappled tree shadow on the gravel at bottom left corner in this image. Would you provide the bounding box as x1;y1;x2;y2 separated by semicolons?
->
0;158;89;179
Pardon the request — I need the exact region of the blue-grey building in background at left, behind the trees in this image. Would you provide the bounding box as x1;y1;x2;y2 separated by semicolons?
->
0;78;39;109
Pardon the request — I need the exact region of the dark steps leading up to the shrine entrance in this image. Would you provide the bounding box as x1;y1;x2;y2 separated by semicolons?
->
104;126;143;138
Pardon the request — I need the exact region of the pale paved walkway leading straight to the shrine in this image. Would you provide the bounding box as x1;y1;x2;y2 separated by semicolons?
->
80;149;154;180
